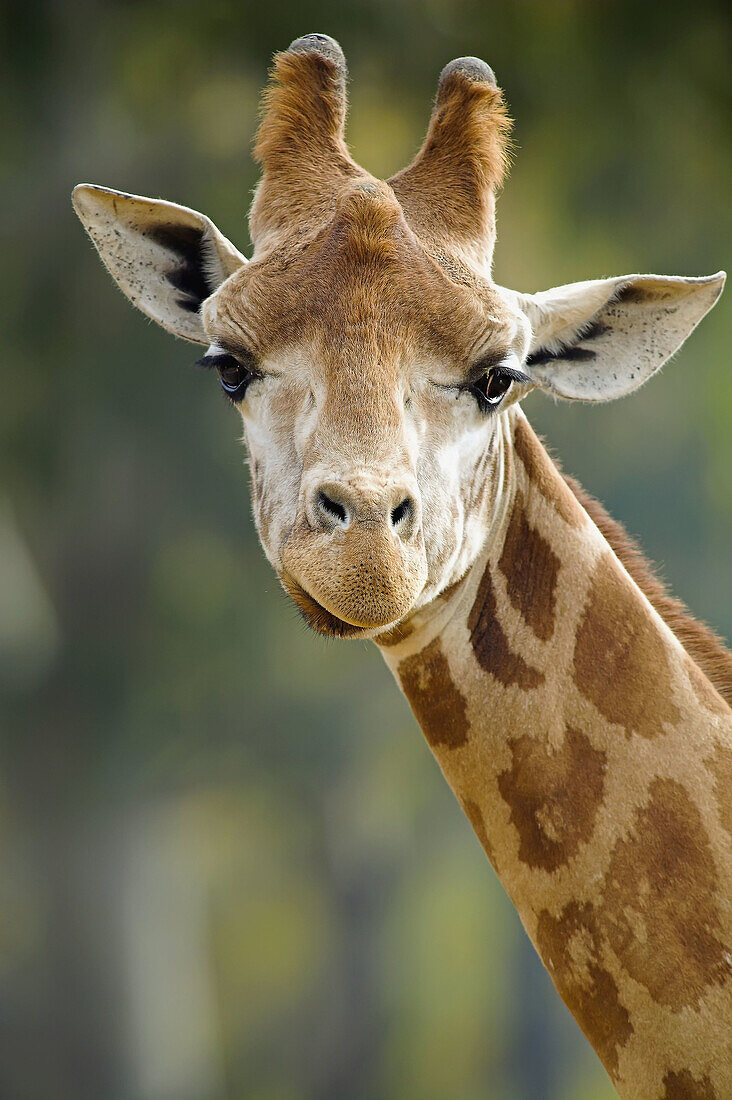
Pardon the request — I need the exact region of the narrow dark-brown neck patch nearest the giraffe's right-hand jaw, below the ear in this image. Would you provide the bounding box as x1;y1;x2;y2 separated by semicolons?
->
499;491;559;641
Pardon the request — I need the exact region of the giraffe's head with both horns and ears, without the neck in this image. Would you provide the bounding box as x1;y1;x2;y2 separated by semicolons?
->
74;34;723;637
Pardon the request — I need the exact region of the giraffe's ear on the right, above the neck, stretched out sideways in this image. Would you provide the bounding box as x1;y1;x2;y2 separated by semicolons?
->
520;272;725;402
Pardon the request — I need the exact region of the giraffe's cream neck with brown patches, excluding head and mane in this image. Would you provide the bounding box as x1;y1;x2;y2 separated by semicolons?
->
382;410;732;1100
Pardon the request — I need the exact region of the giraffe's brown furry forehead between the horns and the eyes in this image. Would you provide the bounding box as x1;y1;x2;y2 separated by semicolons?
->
209;189;510;363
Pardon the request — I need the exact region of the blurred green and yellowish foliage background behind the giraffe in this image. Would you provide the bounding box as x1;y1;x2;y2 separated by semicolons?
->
0;0;732;1100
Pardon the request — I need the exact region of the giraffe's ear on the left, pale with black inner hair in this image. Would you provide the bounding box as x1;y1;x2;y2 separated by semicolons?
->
73;184;247;344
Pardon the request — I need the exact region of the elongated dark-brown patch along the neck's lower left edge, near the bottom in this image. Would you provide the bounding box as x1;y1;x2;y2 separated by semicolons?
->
536;902;634;1080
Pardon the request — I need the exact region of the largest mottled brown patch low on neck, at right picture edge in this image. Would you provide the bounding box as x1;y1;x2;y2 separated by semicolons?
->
598;779;732;1011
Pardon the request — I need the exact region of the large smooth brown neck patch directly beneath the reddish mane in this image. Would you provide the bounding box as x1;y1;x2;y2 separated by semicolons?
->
575;552;679;738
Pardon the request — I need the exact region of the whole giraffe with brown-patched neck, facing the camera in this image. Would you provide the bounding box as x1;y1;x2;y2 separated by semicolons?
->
69;34;732;1100
